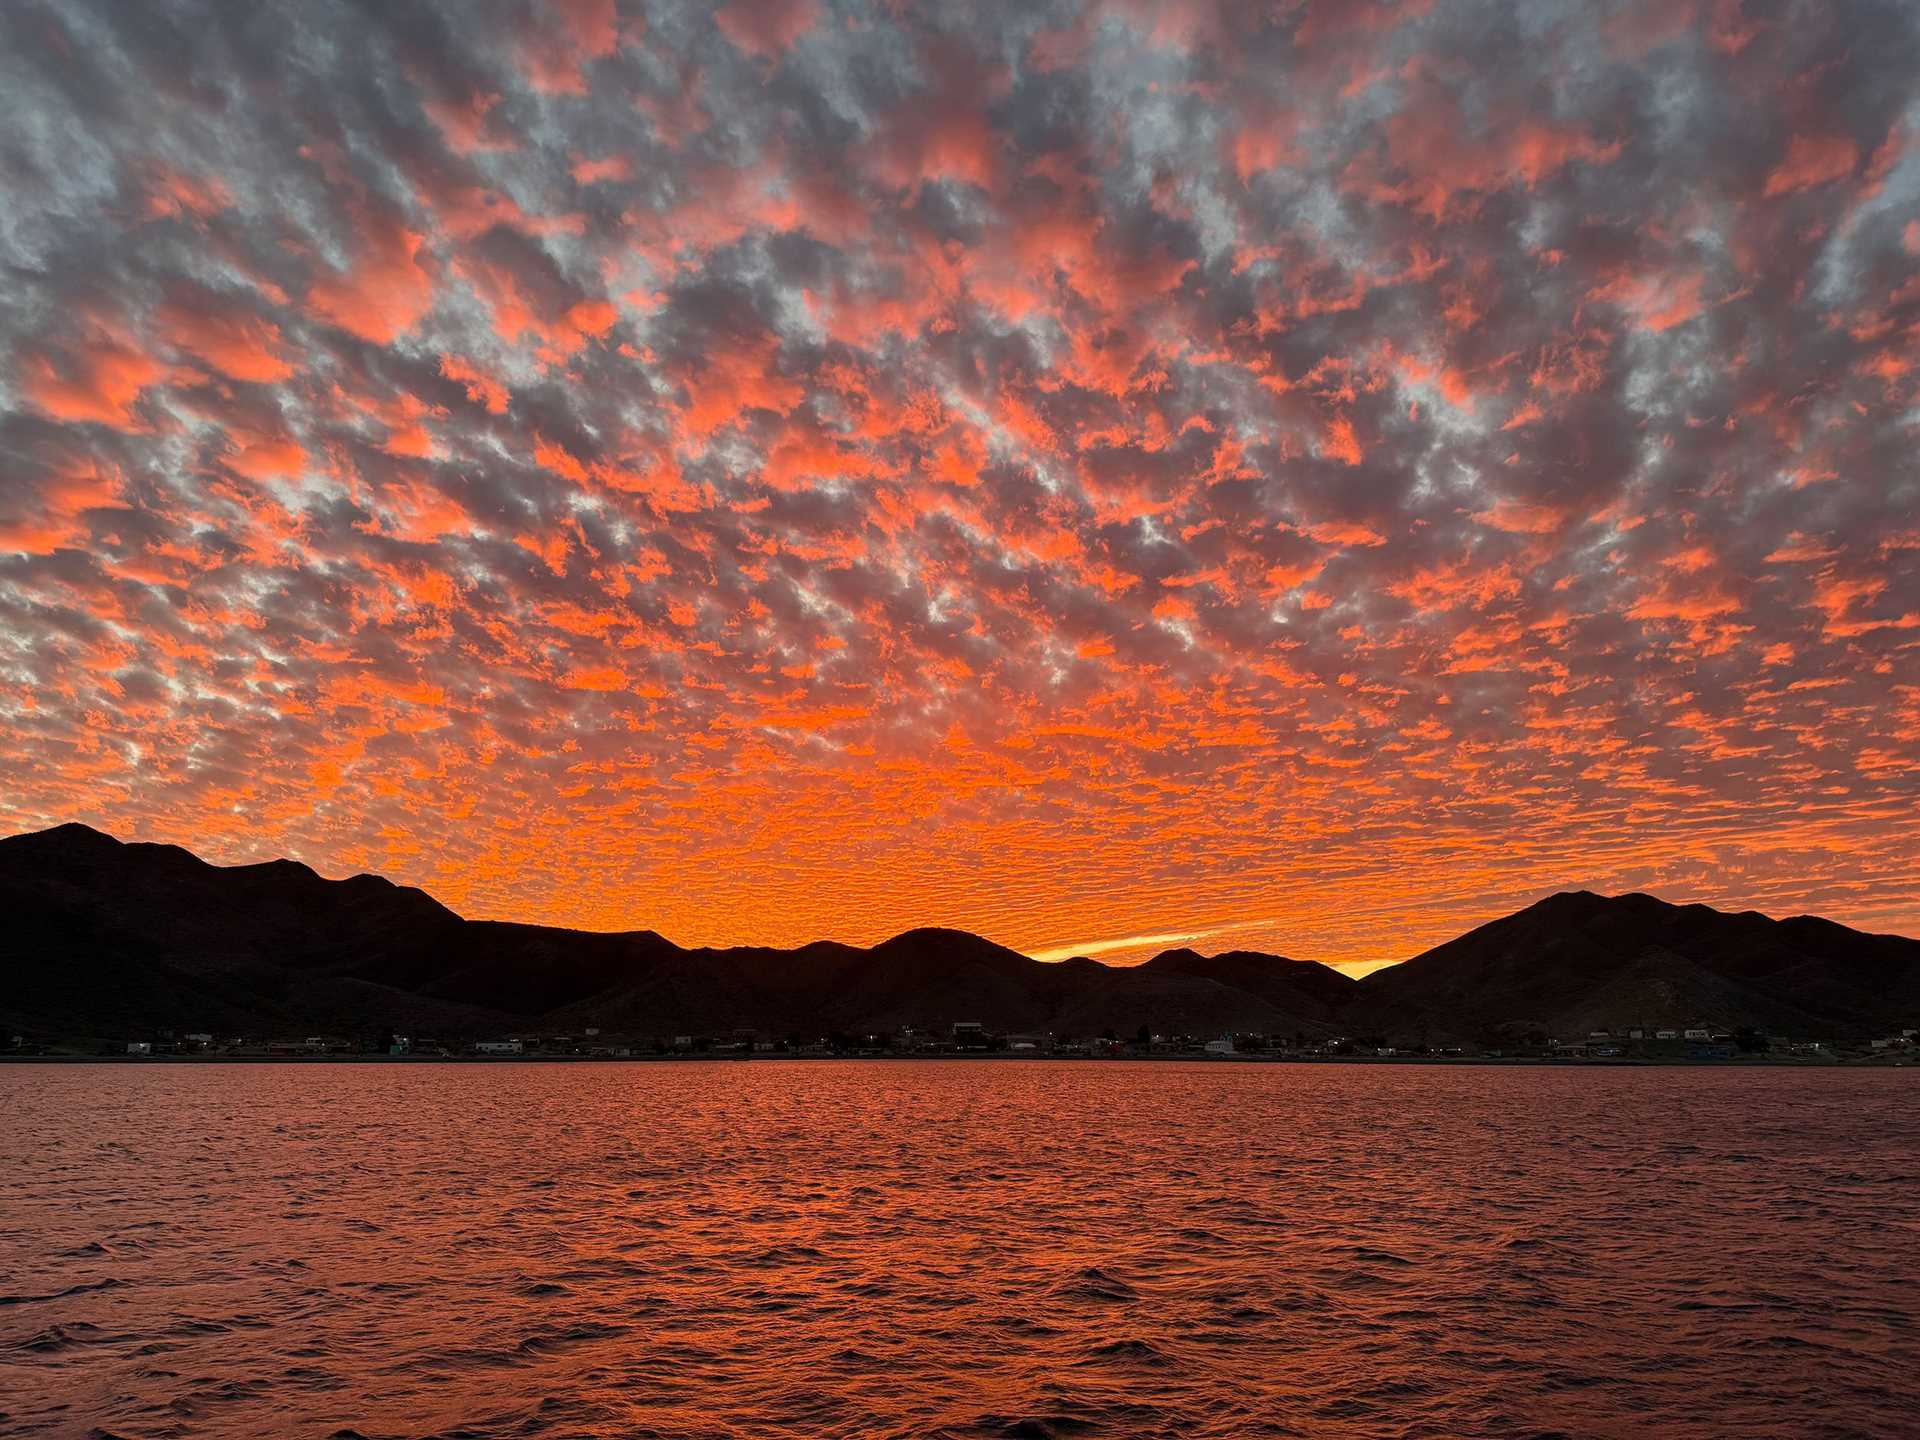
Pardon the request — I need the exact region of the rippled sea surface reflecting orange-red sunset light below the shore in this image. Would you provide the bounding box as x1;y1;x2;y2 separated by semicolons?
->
0;1060;1920;1440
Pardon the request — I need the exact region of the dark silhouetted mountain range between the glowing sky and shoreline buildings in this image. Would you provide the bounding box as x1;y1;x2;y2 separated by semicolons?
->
0;826;1920;1041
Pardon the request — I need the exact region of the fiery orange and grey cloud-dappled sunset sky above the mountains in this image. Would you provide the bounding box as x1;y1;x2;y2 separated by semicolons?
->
0;0;1920;970
